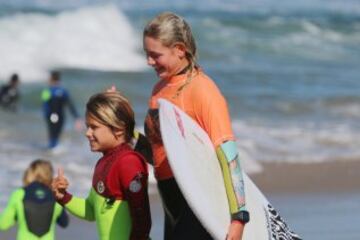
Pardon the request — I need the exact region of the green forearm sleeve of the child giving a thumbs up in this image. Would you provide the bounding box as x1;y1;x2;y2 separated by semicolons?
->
65;192;95;221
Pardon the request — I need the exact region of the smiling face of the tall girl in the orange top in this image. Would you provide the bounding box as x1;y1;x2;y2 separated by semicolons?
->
144;37;189;80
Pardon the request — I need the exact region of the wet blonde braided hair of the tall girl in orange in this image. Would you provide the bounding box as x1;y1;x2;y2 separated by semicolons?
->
143;12;198;70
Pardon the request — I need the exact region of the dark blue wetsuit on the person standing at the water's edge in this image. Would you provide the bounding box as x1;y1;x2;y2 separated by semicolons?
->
41;86;78;148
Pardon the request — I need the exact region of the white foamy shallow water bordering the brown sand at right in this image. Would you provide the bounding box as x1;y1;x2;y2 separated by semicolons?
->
233;121;360;163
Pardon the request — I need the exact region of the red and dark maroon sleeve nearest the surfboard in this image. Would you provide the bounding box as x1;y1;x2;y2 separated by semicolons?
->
118;154;151;240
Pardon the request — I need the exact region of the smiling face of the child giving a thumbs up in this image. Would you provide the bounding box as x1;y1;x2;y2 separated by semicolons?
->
86;114;125;153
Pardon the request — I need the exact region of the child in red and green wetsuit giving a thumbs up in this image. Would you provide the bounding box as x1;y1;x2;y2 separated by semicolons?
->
52;92;151;240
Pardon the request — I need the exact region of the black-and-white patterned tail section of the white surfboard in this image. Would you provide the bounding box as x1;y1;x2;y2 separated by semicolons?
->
264;203;301;240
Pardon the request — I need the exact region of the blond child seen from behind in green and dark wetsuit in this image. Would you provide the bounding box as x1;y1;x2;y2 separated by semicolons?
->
0;159;69;240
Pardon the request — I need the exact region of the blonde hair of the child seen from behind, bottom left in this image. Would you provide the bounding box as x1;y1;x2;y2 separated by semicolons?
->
23;159;53;186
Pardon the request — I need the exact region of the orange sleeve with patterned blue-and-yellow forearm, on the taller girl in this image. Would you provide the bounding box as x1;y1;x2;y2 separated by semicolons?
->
194;79;245;214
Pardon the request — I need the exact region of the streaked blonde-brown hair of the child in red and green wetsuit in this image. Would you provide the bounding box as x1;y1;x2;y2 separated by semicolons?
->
86;92;135;142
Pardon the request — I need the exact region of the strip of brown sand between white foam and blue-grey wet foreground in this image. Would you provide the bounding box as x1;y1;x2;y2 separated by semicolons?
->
251;160;360;193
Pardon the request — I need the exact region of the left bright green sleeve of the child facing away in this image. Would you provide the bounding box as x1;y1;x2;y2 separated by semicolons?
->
0;189;24;231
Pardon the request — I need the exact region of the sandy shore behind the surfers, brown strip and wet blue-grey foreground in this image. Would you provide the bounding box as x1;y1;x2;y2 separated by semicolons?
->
0;161;360;240
